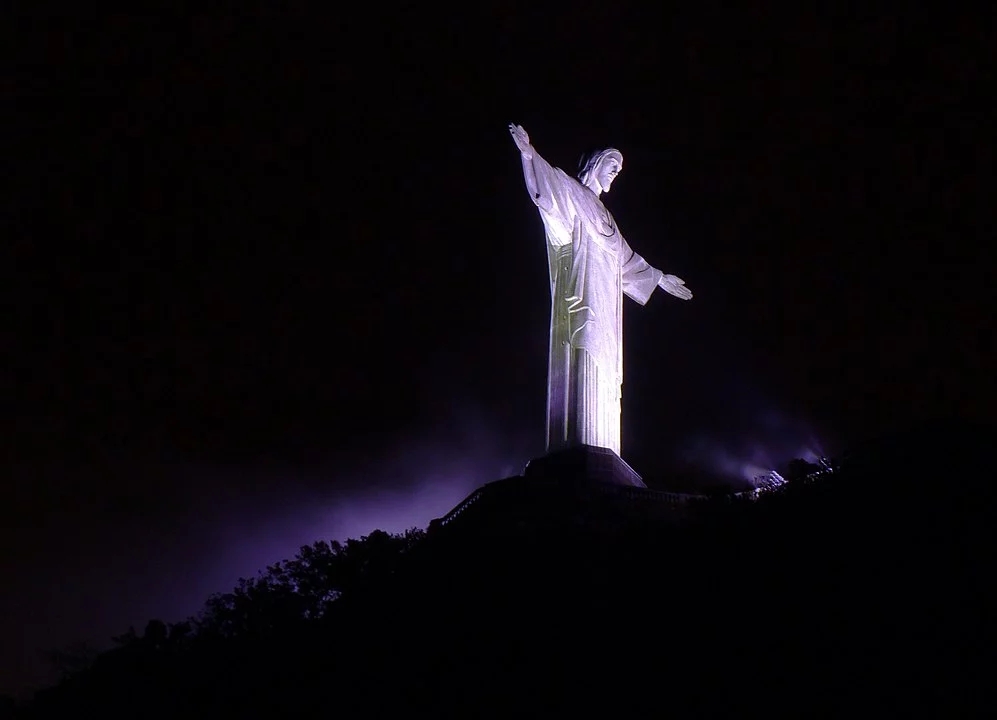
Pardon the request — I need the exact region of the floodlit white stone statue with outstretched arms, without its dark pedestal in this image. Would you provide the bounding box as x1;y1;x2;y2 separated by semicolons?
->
509;125;692;455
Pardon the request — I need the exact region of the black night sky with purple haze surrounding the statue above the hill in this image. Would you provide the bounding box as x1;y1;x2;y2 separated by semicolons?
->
0;2;997;692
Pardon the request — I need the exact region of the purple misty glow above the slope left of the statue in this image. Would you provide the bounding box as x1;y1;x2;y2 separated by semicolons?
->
0;418;532;692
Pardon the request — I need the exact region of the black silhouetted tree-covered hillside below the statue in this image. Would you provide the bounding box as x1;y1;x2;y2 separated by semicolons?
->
11;423;995;718
